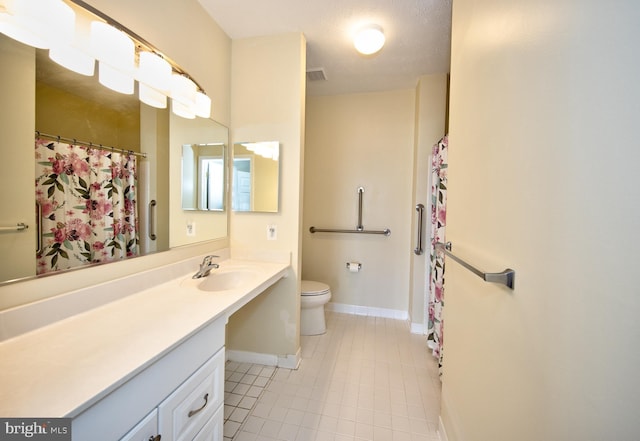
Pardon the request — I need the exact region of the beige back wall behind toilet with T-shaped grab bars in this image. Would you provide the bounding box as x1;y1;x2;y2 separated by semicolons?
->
302;90;415;316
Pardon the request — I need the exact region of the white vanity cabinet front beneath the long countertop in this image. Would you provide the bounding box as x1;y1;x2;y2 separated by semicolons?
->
72;318;226;441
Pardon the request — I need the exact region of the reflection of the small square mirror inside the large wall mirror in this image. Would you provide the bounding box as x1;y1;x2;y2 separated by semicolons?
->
182;141;226;211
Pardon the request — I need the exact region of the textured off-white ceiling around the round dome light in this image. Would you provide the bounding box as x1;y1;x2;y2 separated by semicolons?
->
198;0;451;95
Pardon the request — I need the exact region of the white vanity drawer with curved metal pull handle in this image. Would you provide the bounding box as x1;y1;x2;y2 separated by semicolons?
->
158;348;224;441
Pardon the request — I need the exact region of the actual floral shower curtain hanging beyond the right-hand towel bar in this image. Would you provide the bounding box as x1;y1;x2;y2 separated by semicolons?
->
428;136;448;366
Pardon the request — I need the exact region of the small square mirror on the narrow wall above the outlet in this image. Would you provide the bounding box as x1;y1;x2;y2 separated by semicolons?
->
231;141;280;213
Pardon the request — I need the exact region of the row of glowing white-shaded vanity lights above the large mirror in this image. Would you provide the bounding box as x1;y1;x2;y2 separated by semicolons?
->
0;0;211;118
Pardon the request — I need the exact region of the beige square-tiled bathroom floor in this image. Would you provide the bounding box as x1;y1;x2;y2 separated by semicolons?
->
224;311;440;441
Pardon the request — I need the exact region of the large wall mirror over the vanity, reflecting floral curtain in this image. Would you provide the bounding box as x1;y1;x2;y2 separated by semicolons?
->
0;27;228;284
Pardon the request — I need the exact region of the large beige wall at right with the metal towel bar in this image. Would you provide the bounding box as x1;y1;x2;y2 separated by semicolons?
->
441;0;640;441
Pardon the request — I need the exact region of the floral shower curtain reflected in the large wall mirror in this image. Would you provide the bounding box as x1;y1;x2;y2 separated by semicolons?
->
35;139;139;274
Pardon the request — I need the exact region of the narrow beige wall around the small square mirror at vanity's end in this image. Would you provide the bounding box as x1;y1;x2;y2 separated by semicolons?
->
227;33;306;357
